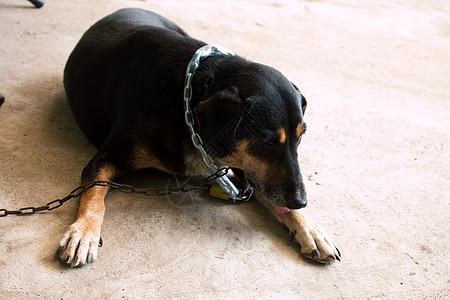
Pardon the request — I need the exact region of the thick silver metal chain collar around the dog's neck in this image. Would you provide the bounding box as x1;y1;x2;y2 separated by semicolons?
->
183;45;253;202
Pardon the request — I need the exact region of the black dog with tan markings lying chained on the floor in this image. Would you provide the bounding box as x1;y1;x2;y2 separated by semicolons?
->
58;9;340;267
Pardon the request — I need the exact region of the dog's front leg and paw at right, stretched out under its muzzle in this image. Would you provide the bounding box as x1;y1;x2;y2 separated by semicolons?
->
257;194;341;263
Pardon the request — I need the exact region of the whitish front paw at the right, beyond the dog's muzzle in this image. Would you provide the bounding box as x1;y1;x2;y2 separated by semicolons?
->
290;222;341;264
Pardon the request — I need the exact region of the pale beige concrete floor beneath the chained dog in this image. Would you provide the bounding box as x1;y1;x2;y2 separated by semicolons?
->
0;0;450;299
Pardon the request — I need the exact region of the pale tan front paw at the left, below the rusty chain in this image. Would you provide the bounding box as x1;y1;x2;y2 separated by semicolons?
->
56;220;102;268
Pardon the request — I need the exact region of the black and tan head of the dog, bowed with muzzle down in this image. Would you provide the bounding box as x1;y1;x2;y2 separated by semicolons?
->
194;64;307;212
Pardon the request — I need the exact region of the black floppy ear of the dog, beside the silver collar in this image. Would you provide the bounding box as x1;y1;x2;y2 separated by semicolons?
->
193;88;243;157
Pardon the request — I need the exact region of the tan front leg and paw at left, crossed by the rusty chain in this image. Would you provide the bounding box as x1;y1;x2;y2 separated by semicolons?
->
57;154;119;267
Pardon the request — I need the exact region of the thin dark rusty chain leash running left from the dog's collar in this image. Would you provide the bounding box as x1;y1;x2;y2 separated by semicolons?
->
0;167;230;217
